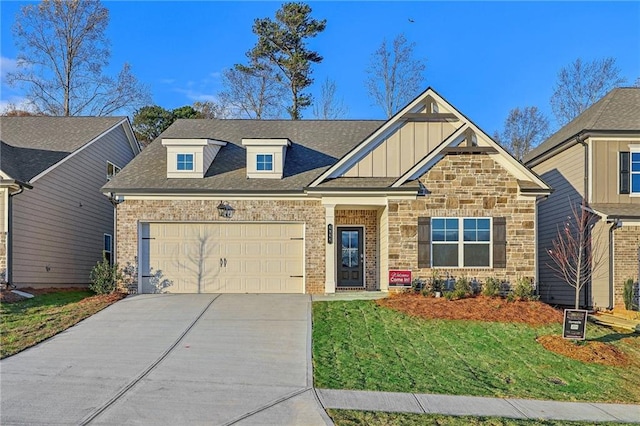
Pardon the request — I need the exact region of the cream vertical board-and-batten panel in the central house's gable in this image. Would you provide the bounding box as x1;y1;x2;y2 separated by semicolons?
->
343;122;459;177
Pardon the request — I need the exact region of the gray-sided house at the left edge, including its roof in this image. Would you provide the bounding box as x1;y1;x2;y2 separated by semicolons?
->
0;117;140;287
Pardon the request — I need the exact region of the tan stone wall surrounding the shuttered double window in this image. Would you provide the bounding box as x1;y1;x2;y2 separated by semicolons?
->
389;154;536;282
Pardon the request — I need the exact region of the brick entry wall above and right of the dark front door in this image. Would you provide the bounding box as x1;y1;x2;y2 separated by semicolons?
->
335;210;379;290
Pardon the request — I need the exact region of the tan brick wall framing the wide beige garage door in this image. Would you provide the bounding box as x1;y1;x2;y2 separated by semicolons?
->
116;199;325;294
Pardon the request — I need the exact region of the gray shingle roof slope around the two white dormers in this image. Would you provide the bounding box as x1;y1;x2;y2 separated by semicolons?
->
103;119;384;192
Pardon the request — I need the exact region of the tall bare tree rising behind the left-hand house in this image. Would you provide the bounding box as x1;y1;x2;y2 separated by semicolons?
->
7;0;150;116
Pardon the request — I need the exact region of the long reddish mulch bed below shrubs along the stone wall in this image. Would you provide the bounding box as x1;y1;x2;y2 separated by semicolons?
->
378;293;562;326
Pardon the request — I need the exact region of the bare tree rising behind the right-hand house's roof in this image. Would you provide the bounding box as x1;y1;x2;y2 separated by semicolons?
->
551;57;625;126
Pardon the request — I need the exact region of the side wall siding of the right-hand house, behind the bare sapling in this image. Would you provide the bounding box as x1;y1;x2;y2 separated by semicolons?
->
533;145;585;306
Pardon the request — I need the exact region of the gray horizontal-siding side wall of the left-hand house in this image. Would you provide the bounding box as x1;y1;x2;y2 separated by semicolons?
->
11;126;134;287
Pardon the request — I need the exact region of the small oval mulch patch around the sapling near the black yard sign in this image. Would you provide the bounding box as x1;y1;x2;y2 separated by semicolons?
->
536;336;630;367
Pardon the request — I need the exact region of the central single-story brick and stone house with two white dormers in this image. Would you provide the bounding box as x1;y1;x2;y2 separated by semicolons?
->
103;89;550;293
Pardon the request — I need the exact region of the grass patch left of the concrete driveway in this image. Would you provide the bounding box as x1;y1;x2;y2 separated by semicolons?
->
0;290;117;358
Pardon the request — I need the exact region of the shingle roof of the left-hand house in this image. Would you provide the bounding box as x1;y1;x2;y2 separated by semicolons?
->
0;117;125;182
